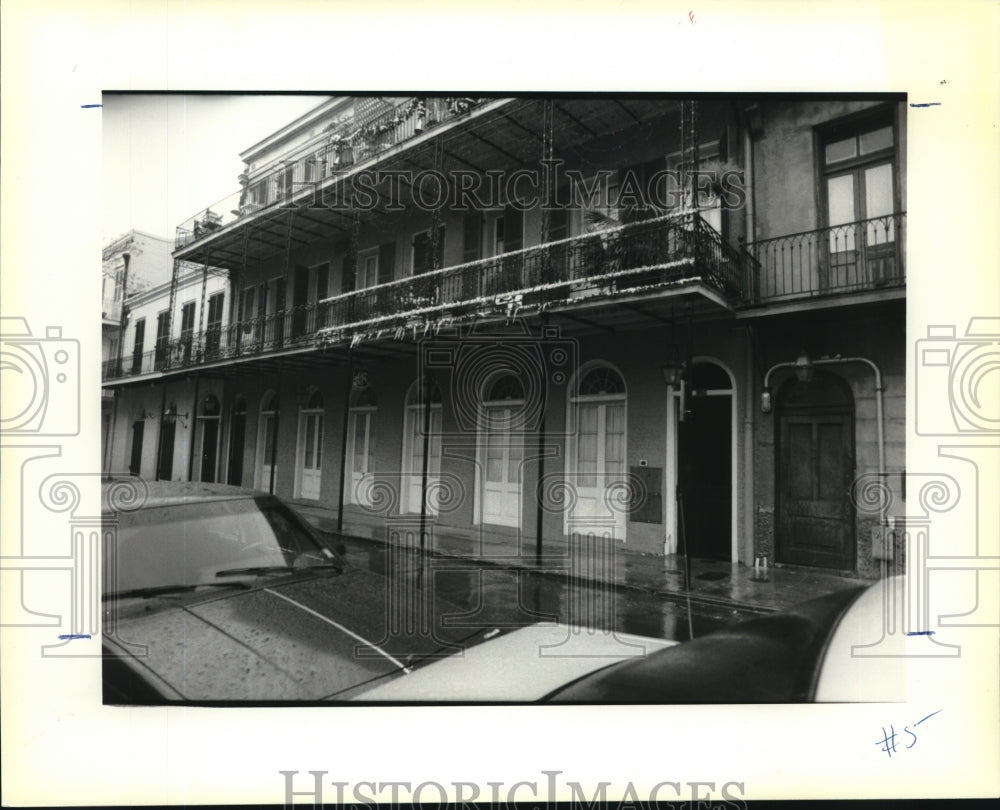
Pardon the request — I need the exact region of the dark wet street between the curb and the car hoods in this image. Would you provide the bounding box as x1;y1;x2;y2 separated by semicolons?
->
341;537;768;641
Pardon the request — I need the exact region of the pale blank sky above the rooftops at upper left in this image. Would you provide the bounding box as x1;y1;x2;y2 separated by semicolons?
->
101;93;326;245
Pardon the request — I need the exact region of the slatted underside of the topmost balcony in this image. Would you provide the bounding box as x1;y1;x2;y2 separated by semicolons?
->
174;96;680;270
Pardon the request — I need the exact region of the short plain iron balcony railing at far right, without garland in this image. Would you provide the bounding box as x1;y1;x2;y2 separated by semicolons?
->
750;213;906;303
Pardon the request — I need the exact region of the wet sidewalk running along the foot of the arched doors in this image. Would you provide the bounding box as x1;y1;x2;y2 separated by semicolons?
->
292;501;872;612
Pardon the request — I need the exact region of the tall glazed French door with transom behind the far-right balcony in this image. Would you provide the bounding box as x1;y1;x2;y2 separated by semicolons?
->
820;112;898;288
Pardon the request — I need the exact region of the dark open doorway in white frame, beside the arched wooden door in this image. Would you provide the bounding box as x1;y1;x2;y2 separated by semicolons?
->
677;362;733;562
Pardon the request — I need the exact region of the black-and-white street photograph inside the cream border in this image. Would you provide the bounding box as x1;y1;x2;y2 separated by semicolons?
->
102;93;923;704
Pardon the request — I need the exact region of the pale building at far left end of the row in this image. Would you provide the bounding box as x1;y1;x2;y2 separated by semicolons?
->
101;230;173;470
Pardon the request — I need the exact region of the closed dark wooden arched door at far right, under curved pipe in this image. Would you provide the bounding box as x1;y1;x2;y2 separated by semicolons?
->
775;371;855;570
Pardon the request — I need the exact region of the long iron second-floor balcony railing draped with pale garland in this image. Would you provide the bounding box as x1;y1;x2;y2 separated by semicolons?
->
103;212;757;380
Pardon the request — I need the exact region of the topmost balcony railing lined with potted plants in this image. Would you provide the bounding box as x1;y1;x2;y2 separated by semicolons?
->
174;97;487;249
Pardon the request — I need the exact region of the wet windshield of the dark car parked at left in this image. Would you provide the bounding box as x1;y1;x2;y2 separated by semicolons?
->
104;498;335;595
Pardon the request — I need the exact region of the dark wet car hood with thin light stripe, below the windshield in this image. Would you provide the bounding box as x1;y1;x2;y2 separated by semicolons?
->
104;570;489;703
